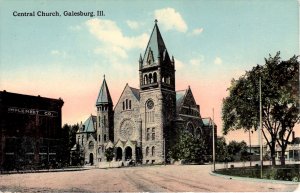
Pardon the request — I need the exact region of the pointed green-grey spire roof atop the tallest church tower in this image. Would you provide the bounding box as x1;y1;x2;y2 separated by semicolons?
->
143;20;169;66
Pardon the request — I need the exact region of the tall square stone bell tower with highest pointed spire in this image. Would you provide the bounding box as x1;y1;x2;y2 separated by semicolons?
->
139;20;176;163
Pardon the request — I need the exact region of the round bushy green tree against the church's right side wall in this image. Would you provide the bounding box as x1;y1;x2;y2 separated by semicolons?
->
170;131;207;163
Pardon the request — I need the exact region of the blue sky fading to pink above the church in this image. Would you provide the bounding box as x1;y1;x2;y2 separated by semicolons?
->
0;0;300;144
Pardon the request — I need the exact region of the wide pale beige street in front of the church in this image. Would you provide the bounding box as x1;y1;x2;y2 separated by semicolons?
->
0;165;298;192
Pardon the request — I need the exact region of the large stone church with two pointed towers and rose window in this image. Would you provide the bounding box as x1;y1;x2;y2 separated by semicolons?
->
76;21;216;165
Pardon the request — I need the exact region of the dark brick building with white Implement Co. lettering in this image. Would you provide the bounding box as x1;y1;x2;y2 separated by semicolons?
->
0;91;64;169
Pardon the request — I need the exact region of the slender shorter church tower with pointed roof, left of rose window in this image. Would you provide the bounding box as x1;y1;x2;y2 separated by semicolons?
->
96;75;114;159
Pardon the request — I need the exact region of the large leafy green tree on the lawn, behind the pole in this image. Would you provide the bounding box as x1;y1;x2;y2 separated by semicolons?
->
222;52;300;165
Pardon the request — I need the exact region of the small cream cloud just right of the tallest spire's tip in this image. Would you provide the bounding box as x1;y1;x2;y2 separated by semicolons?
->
154;8;188;32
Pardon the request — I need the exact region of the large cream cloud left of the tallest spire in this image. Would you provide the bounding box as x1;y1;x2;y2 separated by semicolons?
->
85;18;142;80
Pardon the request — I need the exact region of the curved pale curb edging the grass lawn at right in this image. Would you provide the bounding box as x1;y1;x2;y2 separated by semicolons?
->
209;172;300;185
